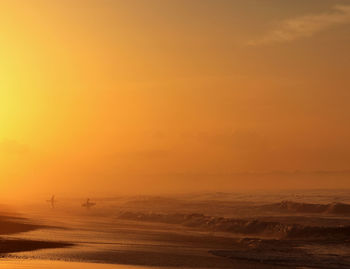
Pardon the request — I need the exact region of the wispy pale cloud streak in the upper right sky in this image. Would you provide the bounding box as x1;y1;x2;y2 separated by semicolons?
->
248;5;350;46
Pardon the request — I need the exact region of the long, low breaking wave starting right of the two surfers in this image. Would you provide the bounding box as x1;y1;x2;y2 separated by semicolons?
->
119;209;350;240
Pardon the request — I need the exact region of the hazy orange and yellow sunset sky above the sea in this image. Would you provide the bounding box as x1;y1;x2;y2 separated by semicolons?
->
0;0;350;197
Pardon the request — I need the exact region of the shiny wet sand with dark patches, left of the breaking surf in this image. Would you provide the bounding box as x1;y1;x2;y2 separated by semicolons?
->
0;210;284;269
